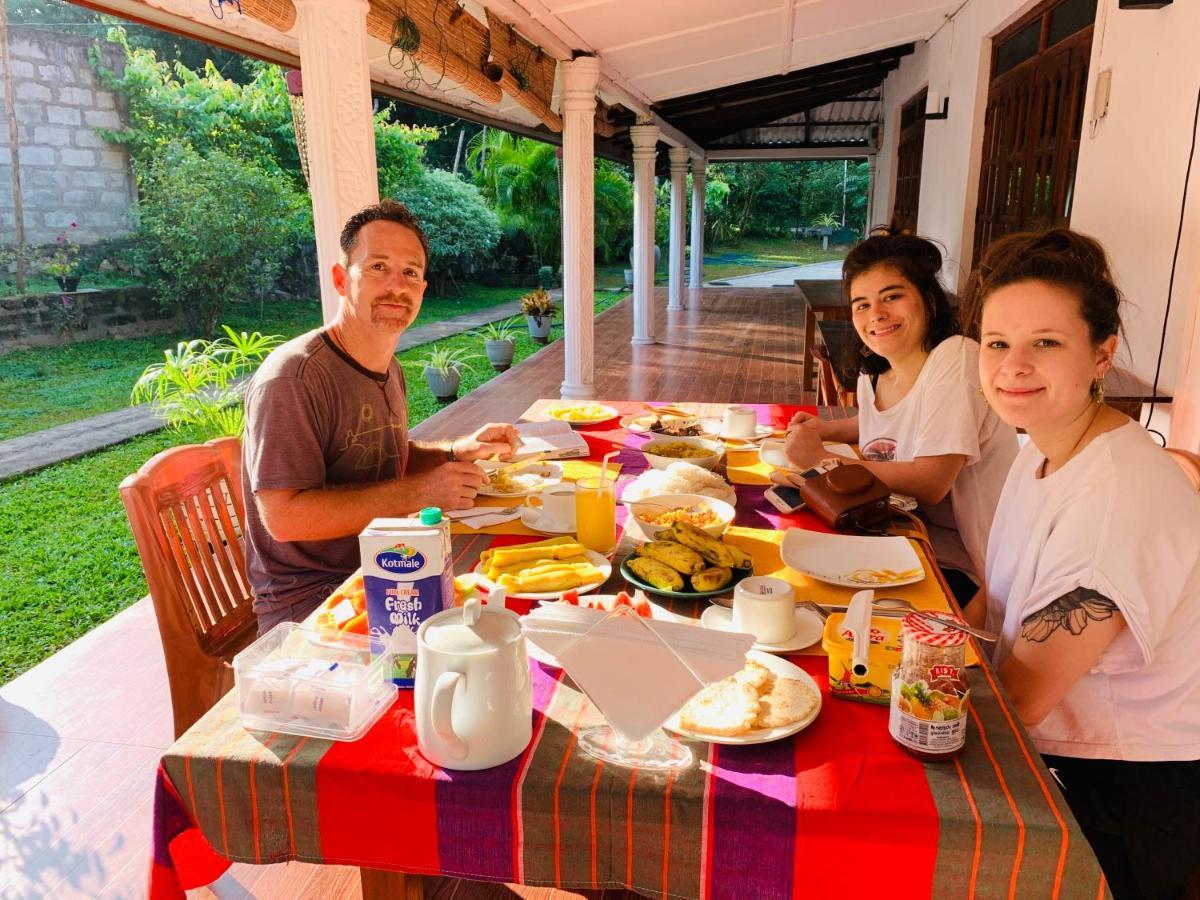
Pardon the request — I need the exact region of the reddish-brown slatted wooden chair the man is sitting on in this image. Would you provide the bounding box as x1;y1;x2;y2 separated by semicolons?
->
120;438;258;738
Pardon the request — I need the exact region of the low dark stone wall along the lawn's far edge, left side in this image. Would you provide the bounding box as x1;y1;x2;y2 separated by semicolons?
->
0;287;184;354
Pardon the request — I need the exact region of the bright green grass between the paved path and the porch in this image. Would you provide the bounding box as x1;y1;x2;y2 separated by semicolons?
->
0;292;623;684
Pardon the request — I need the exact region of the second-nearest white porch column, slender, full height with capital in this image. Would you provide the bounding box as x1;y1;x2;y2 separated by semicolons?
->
558;56;600;400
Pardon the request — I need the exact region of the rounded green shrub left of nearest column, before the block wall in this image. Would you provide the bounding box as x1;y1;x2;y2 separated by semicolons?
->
138;144;304;335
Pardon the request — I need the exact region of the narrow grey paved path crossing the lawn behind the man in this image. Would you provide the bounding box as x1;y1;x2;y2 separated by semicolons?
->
0;297;535;481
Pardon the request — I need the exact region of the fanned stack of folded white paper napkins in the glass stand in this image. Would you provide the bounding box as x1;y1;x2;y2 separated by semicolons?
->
522;604;754;740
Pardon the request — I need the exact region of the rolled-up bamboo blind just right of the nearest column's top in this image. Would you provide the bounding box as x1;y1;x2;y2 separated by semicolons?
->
364;0;502;103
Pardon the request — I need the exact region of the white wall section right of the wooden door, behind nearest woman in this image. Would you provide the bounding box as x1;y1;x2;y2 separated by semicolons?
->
1070;0;1200;450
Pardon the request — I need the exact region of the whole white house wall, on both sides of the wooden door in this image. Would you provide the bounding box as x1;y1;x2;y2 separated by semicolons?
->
874;0;1200;449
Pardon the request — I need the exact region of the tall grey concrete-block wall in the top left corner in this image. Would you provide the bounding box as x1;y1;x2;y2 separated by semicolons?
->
0;25;136;245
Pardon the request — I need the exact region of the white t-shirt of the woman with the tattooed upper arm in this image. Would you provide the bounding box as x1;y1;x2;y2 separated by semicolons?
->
988;422;1200;761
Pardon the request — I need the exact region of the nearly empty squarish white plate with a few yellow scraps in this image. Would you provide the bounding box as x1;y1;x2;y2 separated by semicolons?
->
779;528;925;589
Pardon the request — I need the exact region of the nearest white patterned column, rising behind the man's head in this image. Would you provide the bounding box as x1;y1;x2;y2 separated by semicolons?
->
293;0;379;322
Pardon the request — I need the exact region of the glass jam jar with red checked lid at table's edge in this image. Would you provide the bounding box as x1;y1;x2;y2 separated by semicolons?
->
888;613;970;762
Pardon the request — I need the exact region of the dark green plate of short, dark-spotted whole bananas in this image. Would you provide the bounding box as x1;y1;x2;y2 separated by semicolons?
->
620;522;754;600
